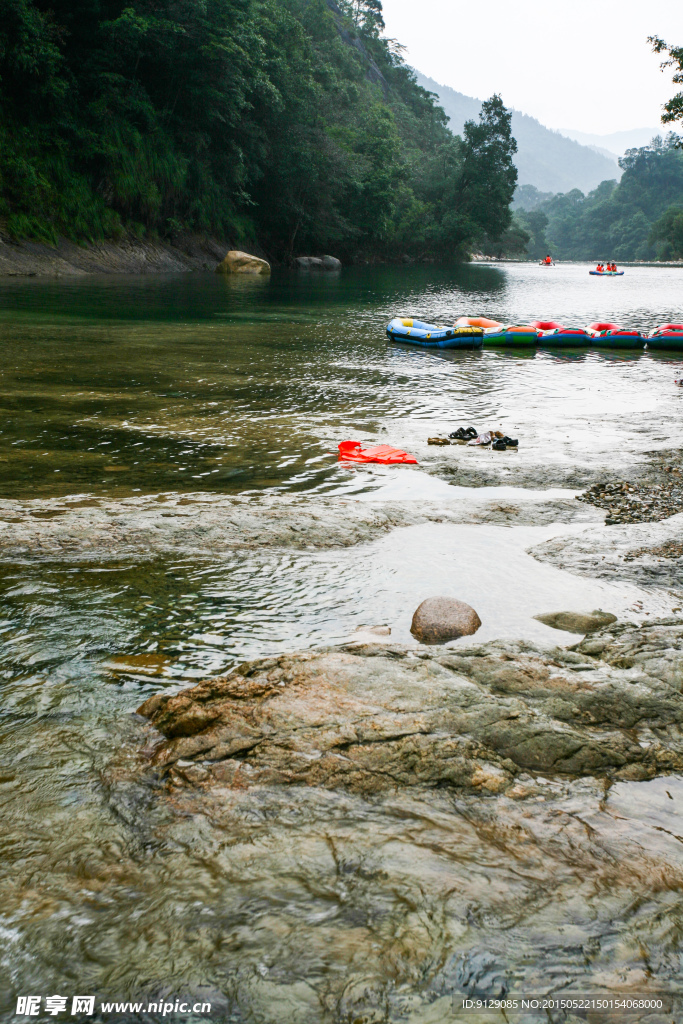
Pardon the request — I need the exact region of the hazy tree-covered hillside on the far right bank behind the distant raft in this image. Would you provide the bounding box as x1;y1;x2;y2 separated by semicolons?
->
515;135;683;260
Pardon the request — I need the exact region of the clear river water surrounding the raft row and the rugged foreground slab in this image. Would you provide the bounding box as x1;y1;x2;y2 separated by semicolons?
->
0;265;683;1024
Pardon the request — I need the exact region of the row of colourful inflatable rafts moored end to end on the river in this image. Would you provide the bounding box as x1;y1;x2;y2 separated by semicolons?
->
387;316;683;350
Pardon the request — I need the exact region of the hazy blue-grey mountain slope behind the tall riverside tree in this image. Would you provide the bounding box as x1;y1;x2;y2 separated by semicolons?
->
416;72;627;193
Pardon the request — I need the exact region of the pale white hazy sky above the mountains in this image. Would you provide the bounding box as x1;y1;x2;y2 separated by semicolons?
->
384;0;683;134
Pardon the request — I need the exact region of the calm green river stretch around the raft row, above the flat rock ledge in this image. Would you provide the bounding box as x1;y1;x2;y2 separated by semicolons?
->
0;265;681;497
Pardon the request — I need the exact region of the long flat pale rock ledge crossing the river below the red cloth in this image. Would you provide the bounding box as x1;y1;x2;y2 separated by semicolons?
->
0;492;601;560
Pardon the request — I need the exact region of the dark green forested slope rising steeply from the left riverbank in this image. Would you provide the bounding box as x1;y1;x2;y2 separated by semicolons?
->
0;0;516;258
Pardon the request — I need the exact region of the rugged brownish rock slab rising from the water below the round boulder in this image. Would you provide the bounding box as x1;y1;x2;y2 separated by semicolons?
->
139;621;683;795
